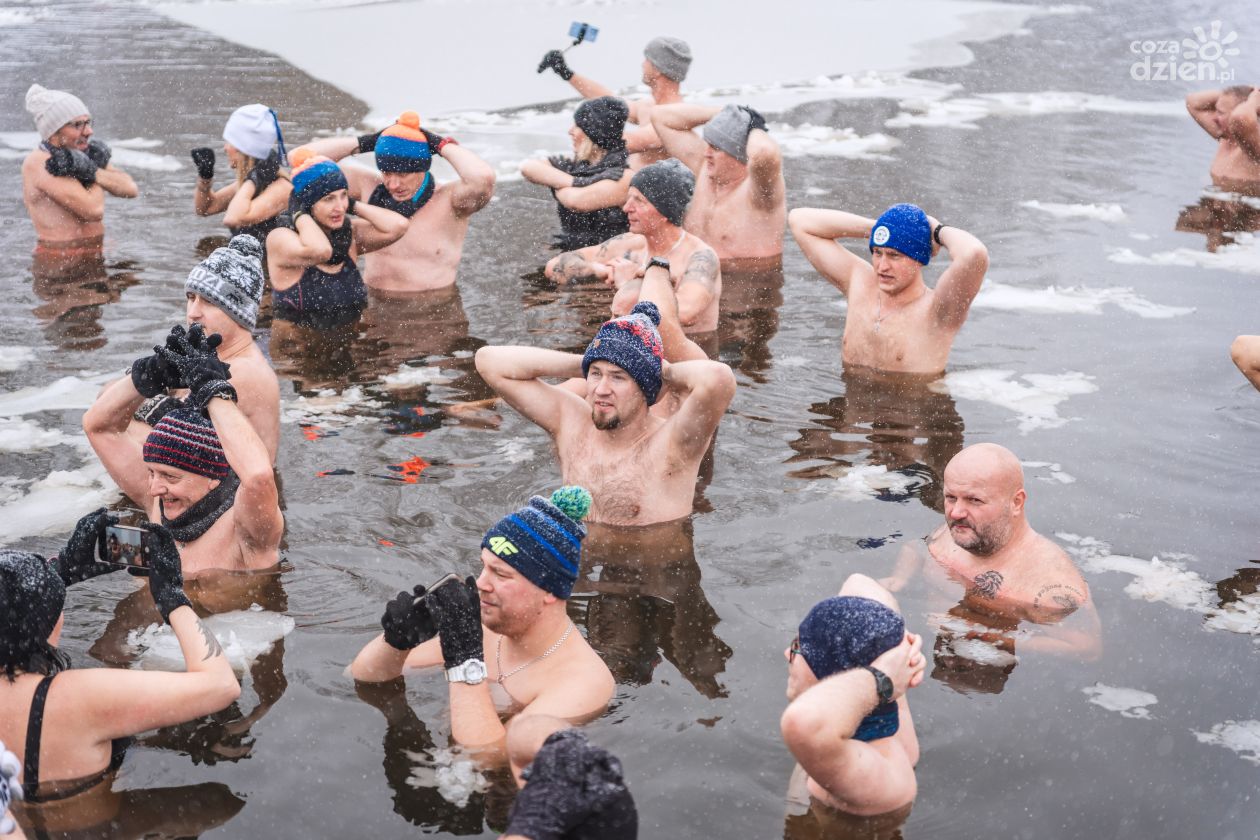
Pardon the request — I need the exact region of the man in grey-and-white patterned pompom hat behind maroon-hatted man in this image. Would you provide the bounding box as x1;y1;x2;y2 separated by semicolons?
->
130;234;280;463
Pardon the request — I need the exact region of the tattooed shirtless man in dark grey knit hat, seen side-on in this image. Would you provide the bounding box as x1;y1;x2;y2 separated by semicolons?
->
546;160;722;332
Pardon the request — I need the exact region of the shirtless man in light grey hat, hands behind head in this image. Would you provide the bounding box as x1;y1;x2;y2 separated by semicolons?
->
651;105;788;262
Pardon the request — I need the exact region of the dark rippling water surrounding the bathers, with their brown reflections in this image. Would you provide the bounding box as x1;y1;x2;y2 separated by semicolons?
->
0;0;1260;839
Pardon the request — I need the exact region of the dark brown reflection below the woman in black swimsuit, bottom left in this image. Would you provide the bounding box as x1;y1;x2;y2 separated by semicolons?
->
14;777;244;840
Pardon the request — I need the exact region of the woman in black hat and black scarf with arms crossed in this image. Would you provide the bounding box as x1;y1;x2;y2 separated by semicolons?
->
520;96;631;251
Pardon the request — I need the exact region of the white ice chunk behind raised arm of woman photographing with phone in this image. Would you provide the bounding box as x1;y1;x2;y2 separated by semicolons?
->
127;604;295;674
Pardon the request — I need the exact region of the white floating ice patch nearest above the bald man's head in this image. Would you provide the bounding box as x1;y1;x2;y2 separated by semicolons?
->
929;368;1097;434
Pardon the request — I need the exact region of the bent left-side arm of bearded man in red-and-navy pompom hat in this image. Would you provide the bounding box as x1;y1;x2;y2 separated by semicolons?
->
475;346;585;434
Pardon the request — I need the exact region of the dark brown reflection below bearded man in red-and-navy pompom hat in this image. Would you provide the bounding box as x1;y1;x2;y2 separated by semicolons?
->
570;519;732;698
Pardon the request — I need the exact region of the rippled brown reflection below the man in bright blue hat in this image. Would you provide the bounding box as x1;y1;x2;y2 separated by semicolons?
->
788;365;963;510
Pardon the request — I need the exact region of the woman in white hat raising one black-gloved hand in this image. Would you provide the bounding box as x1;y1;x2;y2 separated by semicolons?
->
192;103;292;242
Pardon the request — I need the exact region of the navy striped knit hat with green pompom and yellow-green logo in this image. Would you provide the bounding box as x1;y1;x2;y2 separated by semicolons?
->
481;487;591;598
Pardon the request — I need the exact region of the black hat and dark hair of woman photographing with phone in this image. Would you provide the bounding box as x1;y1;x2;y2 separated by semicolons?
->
0;550;71;683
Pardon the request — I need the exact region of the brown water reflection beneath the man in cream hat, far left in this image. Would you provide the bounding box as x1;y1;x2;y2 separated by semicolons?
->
30;237;140;351
